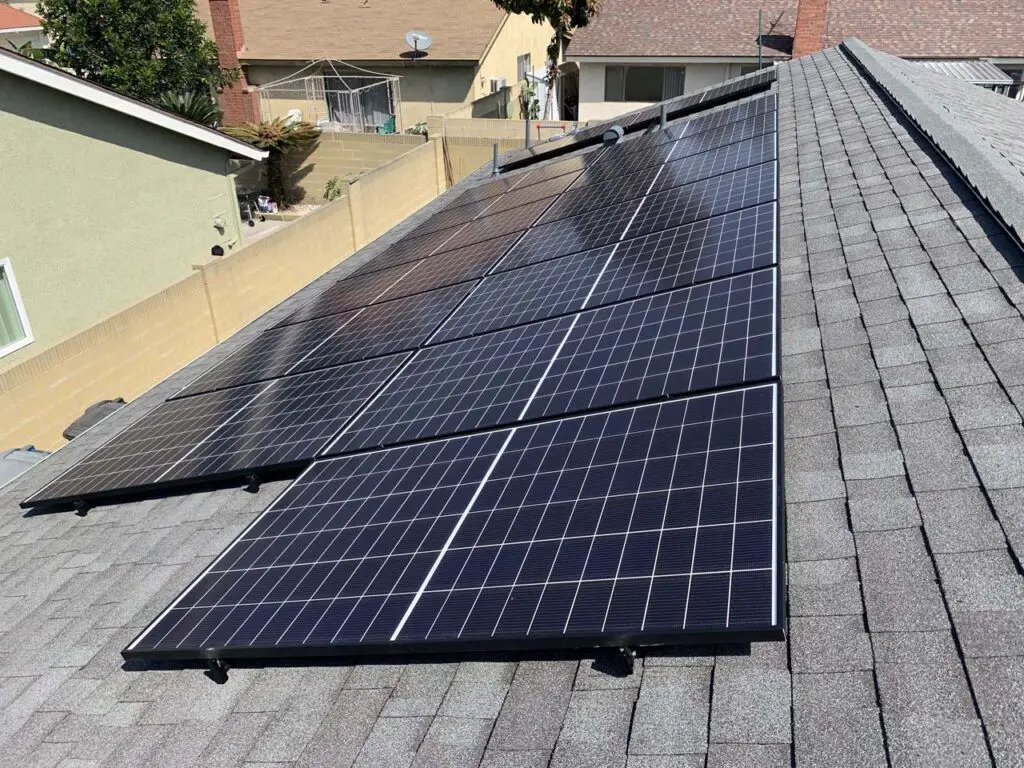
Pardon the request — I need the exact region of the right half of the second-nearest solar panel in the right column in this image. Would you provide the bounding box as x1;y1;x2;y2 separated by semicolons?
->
525;268;776;419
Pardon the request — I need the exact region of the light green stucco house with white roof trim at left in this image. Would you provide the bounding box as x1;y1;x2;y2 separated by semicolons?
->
0;51;265;369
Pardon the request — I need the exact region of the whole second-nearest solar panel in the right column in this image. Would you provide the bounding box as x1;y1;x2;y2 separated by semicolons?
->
325;268;775;455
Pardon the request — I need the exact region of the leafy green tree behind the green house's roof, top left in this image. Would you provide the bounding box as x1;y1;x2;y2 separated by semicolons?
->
39;0;238;101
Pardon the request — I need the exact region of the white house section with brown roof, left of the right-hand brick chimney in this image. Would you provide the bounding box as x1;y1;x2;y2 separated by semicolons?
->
565;0;797;120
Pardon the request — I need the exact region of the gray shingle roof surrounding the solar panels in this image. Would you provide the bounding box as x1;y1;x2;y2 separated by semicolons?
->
0;41;1024;768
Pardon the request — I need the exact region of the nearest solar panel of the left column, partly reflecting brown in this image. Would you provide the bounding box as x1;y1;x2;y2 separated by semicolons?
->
25;354;409;507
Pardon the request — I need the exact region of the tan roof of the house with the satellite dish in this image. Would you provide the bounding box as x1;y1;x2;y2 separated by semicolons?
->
229;0;504;61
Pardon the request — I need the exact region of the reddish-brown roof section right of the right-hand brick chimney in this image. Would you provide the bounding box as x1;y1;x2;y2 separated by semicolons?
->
825;0;1024;58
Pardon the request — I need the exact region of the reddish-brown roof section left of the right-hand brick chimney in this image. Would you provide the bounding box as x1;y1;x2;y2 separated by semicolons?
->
568;0;797;56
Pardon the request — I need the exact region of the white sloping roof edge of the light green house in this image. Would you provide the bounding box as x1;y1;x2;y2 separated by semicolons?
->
0;50;269;160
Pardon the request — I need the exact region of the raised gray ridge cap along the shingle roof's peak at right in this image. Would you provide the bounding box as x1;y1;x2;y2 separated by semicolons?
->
841;38;1024;243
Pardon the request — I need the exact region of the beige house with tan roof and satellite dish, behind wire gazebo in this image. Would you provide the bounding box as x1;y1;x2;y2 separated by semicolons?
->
197;0;551;130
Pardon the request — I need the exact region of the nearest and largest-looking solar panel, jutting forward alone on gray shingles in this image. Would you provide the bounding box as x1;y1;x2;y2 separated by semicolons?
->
123;385;782;658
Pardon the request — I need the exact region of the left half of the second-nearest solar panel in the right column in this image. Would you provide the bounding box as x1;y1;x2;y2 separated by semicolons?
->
325;317;572;456
